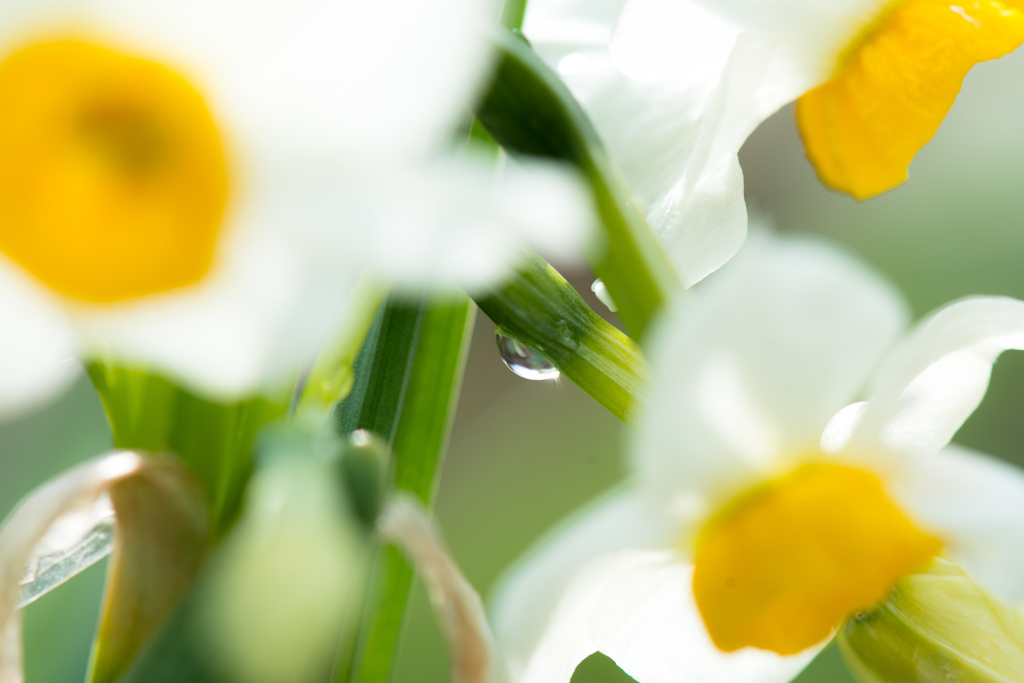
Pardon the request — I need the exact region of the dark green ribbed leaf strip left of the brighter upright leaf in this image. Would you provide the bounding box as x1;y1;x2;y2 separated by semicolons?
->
334;296;425;443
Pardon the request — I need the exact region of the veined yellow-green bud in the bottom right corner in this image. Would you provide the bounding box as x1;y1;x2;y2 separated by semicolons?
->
839;559;1024;683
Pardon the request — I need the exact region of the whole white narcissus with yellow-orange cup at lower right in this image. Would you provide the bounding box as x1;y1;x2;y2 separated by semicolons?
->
494;235;1024;683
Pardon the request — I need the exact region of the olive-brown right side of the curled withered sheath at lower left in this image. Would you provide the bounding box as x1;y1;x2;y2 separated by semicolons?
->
88;459;208;683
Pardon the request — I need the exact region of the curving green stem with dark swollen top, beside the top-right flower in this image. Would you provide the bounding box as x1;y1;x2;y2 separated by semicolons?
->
477;32;679;338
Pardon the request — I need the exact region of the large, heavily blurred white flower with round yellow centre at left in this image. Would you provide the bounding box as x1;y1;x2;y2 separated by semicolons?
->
0;0;587;417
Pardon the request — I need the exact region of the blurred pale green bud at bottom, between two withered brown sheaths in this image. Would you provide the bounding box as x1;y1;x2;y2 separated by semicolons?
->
204;438;368;683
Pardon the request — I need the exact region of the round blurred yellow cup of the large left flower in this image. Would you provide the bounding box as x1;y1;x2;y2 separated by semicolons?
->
0;40;227;303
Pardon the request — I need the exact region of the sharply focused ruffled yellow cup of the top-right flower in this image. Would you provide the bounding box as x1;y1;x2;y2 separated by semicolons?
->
797;0;1024;199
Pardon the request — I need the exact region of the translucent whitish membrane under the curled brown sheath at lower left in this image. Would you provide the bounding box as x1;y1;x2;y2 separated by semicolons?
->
17;496;115;608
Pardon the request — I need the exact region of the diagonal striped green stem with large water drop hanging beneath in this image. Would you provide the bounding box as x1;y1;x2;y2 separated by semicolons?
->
476;256;648;424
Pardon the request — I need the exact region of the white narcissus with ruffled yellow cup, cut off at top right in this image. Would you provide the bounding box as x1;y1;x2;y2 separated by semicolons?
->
524;0;1024;285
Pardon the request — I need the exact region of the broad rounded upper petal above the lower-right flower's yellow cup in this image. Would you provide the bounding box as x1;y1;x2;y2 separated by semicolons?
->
633;239;905;507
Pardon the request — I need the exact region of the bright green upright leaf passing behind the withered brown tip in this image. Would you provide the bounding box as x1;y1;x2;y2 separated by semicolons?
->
334;299;475;683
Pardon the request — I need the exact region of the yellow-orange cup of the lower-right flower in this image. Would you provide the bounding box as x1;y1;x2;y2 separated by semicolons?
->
693;464;940;654
